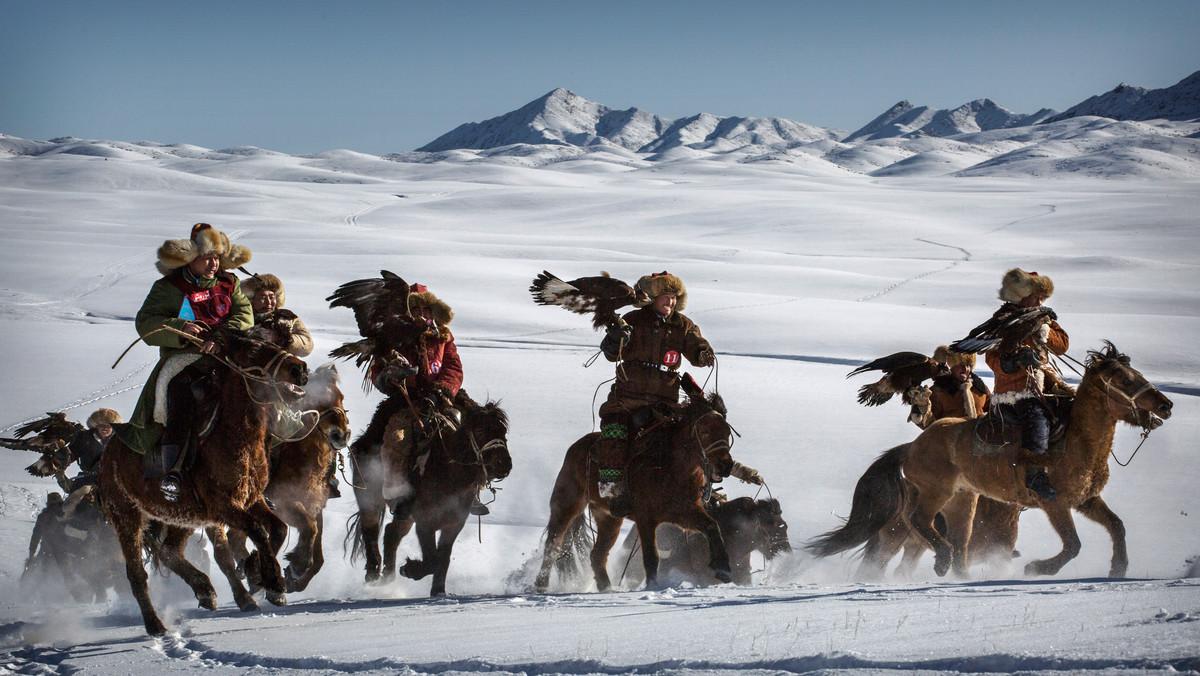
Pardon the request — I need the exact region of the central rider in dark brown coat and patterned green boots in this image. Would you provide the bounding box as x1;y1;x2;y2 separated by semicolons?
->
596;271;716;516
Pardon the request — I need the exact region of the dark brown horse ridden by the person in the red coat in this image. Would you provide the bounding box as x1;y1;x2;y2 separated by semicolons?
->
347;390;512;596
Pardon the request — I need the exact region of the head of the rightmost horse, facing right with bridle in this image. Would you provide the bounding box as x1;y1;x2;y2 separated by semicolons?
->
1080;341;1174;431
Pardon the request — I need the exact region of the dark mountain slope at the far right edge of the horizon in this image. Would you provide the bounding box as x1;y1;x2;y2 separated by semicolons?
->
1045;71;1200;122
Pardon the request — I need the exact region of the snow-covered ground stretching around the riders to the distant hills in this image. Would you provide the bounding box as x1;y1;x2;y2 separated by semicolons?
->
0;144;1200;674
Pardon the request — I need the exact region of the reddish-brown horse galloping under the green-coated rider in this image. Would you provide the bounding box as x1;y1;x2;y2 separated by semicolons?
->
100;329;308;635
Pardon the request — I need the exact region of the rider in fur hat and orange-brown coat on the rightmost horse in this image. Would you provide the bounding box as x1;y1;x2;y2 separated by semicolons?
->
984;268;1069;499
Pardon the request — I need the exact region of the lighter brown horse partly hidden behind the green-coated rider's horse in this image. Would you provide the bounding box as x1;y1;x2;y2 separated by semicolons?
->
206;364;350;602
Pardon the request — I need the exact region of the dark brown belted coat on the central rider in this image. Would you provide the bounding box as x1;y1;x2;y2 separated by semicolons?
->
600;306;713;418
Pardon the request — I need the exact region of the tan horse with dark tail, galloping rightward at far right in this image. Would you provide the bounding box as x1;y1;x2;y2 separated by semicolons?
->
808;342;1171;578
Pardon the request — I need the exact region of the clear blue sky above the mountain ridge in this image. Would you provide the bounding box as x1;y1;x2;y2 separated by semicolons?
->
0;0;1200;155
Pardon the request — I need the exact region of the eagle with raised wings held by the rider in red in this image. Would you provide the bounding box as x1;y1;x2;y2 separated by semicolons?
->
325;270;437;389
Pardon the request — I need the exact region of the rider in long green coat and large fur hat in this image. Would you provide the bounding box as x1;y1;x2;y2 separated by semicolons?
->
118;223;254;502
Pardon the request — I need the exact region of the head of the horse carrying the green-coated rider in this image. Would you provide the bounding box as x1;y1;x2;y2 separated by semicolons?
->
219;328;308;403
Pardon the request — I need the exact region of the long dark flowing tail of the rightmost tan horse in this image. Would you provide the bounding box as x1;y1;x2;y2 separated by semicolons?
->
804;443;910;557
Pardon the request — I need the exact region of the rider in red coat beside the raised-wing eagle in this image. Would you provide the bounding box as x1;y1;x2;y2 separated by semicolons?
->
370;283;463;519
